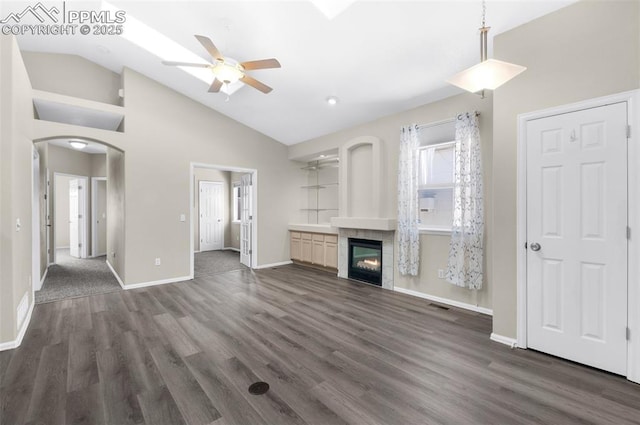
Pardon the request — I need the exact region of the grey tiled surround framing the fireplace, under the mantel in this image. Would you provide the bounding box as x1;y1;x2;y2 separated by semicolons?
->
338;228;395;289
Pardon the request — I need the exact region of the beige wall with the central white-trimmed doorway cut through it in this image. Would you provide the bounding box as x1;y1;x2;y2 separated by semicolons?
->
124;69;300;284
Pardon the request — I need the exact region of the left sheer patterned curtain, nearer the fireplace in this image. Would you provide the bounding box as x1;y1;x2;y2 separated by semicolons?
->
398;124;420;276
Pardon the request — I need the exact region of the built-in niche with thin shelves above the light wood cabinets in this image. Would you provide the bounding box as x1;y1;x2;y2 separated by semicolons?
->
300;155;340;224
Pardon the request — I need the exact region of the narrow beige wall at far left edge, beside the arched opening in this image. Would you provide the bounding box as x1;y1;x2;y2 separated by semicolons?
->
0;36;33;343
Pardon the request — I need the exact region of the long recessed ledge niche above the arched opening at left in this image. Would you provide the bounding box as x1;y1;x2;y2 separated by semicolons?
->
33;90;125;133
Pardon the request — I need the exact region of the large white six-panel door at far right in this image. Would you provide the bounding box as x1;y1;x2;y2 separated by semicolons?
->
526;103;627;374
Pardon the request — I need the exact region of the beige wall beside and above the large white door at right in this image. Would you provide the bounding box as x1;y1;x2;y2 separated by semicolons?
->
493;1;640;338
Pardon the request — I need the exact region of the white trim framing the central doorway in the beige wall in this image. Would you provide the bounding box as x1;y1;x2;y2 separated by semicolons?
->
189;162;258;279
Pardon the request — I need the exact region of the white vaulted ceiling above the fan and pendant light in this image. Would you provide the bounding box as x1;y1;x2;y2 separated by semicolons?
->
0;0;574;145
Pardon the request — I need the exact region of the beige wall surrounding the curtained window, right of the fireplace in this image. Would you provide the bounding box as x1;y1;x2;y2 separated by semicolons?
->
289;94;493;308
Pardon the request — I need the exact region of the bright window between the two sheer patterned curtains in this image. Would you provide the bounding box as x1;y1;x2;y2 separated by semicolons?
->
418;122;455;231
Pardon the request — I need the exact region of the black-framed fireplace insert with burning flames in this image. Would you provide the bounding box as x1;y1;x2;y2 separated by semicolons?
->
348;238;382;286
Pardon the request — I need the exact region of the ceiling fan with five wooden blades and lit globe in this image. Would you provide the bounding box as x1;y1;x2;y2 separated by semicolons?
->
162;35;280;93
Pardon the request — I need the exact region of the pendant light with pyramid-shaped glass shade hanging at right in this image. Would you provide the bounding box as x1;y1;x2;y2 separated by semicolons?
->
447;0;527;98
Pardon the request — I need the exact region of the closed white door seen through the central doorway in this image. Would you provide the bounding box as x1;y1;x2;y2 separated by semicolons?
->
199;181;224;251
